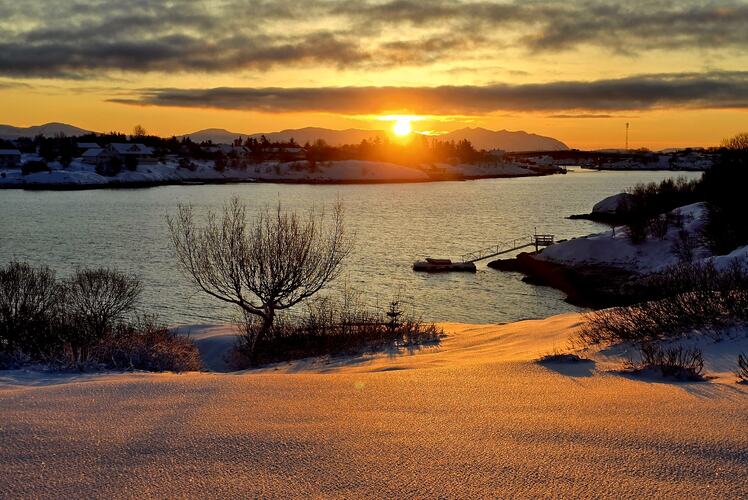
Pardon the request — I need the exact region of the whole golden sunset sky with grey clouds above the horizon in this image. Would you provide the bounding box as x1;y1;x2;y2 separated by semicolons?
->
0;0;748;149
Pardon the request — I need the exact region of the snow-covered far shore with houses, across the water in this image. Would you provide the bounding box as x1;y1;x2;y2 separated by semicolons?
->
0;160;539;188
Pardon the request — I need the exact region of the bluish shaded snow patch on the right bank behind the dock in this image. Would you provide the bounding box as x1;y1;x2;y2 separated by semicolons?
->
537;200;711;273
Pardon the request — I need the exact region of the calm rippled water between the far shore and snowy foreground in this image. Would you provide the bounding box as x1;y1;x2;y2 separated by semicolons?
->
0;169;699;324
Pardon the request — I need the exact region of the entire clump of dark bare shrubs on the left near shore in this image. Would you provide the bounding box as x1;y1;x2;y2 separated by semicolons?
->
0;262;201;371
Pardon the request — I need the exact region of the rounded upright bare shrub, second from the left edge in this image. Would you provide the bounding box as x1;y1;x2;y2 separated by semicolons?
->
58;268;142;363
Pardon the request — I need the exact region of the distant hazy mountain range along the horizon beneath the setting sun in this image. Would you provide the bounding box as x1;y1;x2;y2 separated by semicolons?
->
0;123;569;151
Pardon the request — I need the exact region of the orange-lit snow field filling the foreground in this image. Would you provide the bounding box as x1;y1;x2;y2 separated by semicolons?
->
0;314;748;498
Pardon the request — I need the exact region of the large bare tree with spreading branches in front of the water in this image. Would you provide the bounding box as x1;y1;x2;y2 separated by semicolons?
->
167;197;352;352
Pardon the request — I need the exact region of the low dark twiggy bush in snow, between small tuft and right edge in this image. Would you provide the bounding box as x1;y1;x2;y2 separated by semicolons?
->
636;343;704;381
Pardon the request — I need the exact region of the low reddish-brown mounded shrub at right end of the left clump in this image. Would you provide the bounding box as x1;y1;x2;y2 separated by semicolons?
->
93;317;203;372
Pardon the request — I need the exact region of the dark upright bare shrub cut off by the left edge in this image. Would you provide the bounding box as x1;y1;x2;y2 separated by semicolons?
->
0;262;60;354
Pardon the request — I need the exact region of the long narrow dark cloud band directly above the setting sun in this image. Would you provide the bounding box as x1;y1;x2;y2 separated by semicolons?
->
112;72;748;115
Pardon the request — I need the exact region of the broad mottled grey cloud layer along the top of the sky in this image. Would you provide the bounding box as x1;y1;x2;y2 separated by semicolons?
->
0;0;748;78
